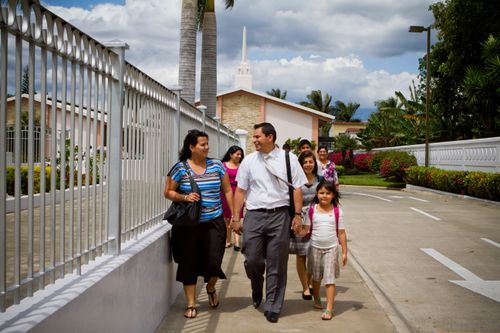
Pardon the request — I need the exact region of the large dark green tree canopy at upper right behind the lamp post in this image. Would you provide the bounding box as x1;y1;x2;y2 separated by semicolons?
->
420;0;500;140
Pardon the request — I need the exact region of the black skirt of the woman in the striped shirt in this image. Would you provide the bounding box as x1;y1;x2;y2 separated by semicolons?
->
172;216;226;285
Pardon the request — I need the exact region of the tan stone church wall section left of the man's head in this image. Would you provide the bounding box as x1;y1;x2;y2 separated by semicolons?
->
218;93;263;153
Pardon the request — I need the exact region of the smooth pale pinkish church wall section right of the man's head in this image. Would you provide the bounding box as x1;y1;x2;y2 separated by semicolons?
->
266;102;314;147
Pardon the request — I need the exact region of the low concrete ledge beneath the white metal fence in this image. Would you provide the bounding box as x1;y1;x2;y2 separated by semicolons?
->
0;223;182;333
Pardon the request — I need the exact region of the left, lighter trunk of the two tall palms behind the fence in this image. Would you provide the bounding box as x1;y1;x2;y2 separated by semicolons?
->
179;0;198;104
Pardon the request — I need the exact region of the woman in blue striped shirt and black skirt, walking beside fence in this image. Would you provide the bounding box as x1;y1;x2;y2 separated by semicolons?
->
164;130;233;318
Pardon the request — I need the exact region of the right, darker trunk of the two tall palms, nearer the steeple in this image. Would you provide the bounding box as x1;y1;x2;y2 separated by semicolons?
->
198;0;234;117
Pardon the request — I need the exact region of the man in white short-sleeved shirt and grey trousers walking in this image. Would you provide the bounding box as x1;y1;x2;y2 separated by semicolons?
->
231;123;307;323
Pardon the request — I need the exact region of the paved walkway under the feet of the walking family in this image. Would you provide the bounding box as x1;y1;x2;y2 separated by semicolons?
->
157;243;395;333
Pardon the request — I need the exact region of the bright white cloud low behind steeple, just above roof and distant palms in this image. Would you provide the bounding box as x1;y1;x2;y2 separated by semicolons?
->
219;55;416;107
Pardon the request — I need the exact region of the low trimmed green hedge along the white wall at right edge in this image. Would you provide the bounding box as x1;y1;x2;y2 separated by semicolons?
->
405;166;500;201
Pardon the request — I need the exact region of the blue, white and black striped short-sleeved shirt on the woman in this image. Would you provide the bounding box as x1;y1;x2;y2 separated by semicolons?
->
168;159;226;222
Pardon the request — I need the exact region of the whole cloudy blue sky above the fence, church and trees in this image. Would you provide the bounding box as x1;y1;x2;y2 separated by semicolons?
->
41;0;436;114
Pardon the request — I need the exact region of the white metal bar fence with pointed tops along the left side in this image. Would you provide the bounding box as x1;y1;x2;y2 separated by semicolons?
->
0;0;237;311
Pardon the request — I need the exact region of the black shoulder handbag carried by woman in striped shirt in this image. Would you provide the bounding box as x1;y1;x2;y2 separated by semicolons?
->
163;162;201;226
